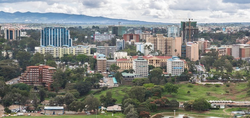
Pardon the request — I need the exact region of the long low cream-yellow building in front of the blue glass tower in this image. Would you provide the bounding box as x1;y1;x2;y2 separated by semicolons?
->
35;45;91;58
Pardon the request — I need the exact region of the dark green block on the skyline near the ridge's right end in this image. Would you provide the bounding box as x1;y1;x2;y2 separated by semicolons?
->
108;26;127;36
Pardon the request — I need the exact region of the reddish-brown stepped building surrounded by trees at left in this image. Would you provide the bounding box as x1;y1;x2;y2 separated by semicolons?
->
20;65;56;88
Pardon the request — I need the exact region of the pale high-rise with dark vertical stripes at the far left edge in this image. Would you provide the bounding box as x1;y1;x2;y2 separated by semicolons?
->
4;28;21;40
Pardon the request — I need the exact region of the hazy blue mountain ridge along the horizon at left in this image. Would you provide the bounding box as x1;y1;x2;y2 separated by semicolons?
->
0;11;161;24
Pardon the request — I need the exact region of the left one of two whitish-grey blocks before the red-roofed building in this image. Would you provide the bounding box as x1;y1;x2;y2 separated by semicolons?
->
133;56;148;77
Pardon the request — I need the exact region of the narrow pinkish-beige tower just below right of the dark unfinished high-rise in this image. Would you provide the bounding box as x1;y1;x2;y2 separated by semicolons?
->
186;42;199;61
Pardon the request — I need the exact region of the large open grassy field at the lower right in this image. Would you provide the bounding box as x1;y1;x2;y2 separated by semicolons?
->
162;83;250;101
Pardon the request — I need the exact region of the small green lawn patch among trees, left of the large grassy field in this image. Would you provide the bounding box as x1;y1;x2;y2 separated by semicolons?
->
94;86;131;104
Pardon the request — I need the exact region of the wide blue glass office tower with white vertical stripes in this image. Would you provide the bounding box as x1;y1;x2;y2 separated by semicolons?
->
40;27;72;47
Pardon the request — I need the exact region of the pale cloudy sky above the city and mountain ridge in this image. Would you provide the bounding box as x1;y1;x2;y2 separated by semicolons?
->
0;0;250;23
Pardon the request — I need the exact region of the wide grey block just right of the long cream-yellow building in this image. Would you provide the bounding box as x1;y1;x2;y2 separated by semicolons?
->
96;46;116;58
